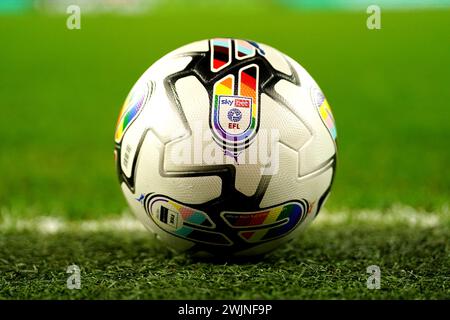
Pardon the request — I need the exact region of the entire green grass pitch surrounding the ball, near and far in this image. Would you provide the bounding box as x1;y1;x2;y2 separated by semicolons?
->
0;8;450;299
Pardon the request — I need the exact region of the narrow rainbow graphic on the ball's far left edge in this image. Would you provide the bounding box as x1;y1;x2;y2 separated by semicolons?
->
115;84;149;143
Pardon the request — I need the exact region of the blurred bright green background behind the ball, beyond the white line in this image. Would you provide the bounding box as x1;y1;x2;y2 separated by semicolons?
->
0;0;450;219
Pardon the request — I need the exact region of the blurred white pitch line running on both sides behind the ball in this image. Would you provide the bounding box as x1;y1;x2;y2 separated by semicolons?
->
0;206;450;234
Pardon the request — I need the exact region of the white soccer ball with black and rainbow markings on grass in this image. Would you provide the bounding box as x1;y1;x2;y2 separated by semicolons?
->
115;38;337;256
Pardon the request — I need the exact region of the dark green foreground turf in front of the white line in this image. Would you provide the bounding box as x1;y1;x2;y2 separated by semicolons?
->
0;211;450;299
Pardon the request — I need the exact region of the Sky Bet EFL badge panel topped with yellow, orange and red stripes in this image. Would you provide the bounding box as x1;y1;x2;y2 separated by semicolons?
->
211;64;259;158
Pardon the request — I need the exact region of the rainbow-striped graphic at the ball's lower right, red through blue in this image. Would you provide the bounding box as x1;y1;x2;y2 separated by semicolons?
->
222;200;309;243
